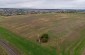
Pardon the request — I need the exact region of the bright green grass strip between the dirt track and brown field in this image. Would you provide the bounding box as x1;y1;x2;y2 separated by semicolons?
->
0;27;56;55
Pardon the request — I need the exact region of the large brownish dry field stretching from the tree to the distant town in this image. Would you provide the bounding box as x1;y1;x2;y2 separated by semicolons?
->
0;13;85;55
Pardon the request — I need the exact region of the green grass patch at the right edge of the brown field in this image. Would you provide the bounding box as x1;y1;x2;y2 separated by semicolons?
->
74;29;85;55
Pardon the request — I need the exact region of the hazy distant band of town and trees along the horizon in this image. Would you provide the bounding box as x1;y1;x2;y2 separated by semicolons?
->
0;8;85;16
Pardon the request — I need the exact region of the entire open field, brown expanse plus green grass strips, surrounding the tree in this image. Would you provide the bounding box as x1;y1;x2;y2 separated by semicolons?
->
0;13;85;55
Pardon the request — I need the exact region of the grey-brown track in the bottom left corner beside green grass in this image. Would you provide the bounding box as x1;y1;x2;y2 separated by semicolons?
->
0;40;18;55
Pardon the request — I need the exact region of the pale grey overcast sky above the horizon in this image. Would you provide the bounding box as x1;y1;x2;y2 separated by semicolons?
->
0;0;85;9
